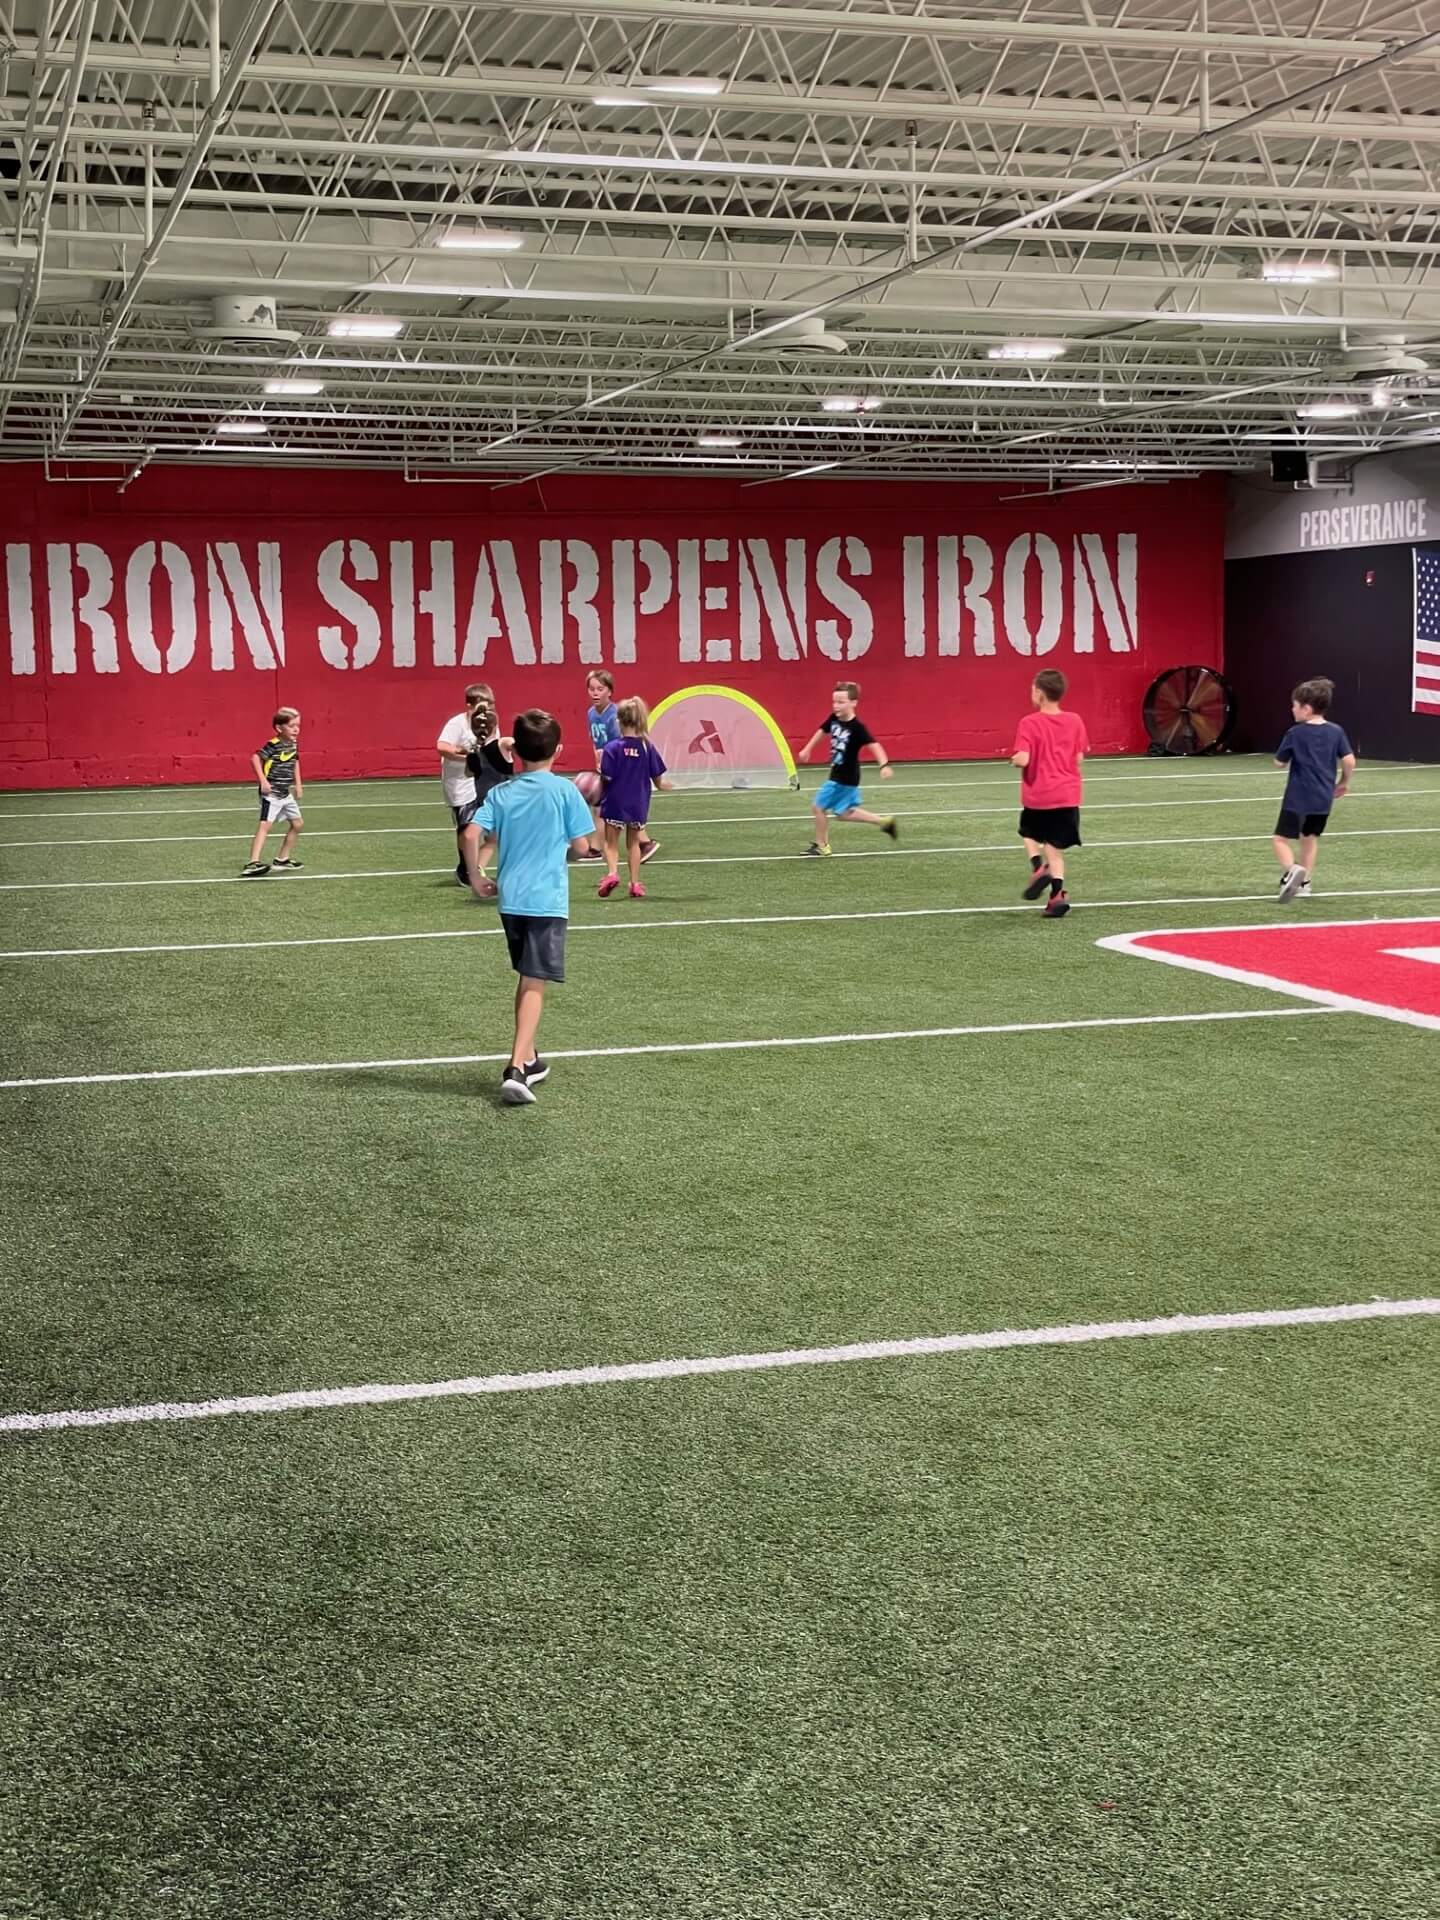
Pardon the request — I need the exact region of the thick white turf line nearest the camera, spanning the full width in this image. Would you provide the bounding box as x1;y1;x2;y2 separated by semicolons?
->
0;1298;1440;1434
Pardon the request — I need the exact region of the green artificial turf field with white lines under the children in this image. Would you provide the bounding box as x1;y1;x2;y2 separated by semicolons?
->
0;756;1440;1920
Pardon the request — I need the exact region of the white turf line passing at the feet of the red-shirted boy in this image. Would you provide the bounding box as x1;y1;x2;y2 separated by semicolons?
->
0;887;1440;960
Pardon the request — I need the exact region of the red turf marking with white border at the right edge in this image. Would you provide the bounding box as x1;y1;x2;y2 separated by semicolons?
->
1096;920;1440;1029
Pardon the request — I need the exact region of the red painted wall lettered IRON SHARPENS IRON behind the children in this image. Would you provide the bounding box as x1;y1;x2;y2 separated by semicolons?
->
0;467;1223;787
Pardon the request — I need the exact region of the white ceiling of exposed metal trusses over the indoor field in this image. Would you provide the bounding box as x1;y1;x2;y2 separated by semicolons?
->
0;0;1440;486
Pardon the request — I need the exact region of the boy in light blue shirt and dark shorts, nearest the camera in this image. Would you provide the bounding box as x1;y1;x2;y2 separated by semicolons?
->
474;707;589;1106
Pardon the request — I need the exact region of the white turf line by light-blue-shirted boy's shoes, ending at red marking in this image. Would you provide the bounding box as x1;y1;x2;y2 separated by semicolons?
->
0;1006;1334;1089
